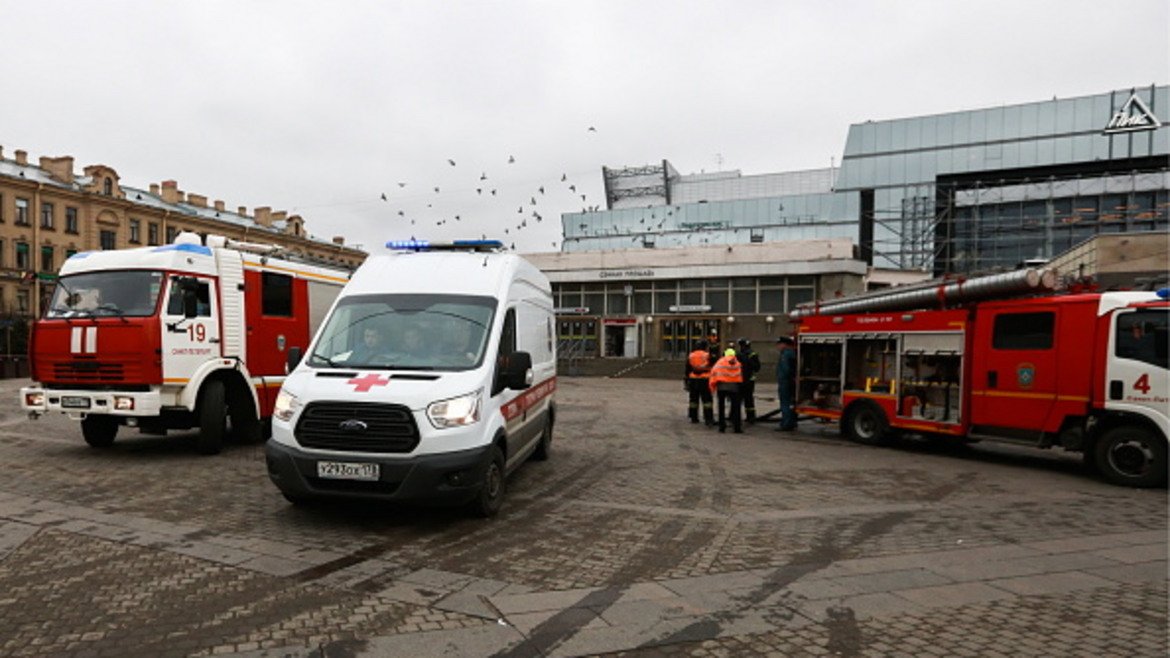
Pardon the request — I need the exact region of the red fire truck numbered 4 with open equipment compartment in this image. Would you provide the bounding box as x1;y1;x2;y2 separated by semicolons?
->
792;269;1170;487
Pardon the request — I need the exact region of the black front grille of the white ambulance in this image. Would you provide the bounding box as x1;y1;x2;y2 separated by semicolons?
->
294;402;419;453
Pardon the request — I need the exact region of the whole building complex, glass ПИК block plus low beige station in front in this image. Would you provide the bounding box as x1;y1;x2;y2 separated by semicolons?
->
528;85;1170;358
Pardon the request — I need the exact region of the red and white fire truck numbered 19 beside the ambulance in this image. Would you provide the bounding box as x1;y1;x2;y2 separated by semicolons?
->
20;233;349;454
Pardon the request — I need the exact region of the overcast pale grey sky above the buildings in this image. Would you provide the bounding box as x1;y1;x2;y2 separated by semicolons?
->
0;0;1170;252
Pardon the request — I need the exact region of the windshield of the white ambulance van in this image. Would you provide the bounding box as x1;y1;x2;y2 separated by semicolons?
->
308;294;496;370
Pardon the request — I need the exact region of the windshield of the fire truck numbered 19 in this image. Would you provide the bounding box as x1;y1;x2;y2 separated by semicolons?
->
44;269;166;317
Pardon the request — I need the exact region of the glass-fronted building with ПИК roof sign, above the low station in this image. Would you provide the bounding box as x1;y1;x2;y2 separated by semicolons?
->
562;85;1170;274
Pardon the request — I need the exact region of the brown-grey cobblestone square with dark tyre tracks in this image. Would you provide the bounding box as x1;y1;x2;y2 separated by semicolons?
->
0;378;1168;657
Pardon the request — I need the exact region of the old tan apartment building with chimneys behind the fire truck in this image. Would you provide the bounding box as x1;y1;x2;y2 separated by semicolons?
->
0;146;366;317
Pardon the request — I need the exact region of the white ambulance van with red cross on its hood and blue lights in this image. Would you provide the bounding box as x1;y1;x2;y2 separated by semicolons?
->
267;240;557;516
